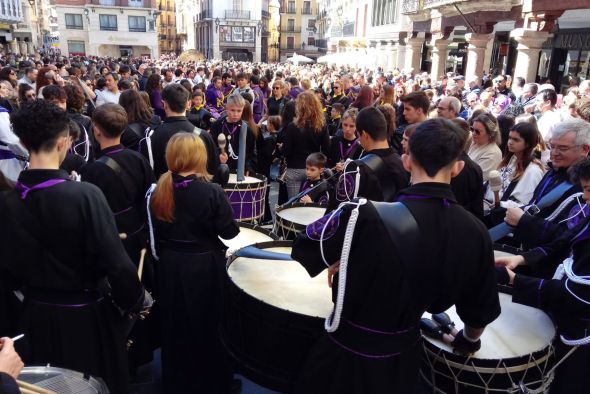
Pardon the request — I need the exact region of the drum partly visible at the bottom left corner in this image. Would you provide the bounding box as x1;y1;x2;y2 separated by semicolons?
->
18;366;109;394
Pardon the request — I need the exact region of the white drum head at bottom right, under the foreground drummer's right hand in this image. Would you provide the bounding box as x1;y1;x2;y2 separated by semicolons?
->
423;293;555;360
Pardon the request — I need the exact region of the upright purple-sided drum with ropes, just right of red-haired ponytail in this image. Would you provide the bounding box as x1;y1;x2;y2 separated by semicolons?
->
223;174;266;222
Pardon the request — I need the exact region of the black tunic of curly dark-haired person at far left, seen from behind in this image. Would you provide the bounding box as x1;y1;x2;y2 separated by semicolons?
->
0;170;143;393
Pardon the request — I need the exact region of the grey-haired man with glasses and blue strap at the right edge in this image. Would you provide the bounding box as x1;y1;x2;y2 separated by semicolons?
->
504;119;590;249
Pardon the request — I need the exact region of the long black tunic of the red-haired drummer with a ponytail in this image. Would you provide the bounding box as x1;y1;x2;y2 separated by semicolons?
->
153;175;239;394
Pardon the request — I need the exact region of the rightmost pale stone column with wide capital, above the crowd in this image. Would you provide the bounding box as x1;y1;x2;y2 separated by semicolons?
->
510;28;553;82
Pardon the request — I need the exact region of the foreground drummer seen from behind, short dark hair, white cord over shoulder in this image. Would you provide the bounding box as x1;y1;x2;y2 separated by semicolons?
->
292;118;500;393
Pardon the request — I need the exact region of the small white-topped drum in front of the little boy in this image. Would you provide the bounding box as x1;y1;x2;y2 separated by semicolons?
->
273;203;326;239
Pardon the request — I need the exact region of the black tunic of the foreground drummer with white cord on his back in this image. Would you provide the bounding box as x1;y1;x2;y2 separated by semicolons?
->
292;183;500;393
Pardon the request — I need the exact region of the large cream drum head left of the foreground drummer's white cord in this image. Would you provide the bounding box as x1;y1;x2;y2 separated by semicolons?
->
228;247;333;318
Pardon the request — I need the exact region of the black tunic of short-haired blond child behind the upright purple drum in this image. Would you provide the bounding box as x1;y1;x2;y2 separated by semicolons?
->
211;118;256;174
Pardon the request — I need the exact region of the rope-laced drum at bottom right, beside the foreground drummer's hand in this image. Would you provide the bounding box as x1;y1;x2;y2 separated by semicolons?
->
420;293;555;394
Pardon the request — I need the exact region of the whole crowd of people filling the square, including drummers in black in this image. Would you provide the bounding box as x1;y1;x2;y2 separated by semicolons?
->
0;51;590;393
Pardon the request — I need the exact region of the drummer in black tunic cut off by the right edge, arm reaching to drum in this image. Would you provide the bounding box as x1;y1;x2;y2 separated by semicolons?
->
496;158;590;393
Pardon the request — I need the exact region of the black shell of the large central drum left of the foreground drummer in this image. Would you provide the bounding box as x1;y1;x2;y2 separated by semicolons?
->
221;241;324;392
